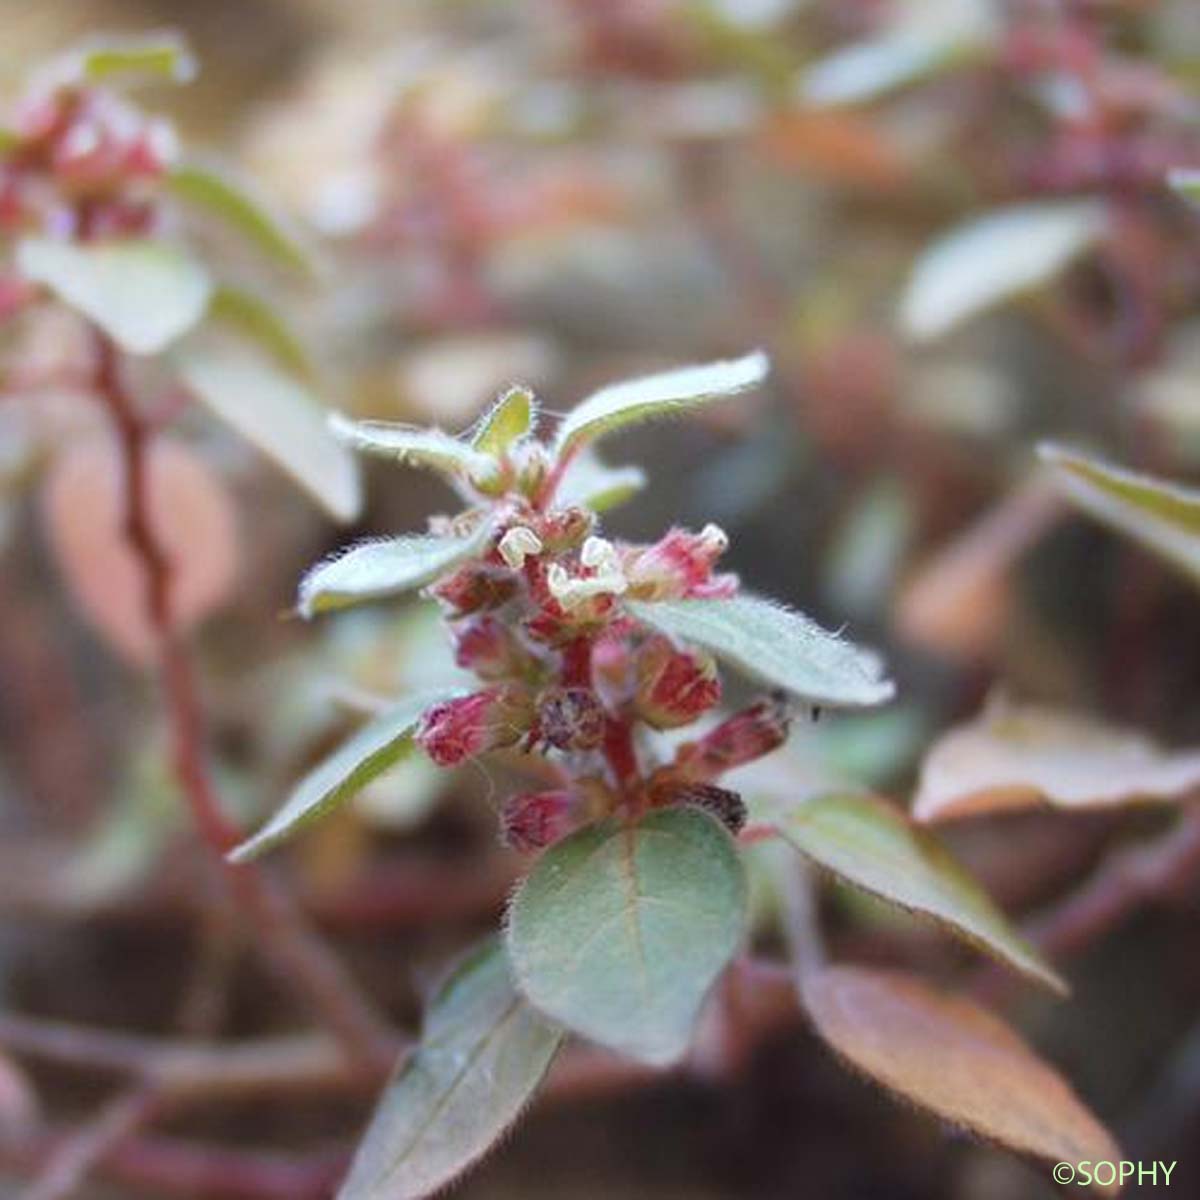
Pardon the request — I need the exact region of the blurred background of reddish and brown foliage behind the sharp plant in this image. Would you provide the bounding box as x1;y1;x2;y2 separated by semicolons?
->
0;0;1200;1200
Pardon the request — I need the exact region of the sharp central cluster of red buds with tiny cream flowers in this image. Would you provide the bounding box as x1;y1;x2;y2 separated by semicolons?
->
415;482;788;851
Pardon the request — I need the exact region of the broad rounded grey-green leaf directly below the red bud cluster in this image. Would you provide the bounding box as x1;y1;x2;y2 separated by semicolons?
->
508;808;746;1064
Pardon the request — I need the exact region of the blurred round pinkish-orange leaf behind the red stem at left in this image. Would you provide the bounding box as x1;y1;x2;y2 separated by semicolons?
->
42;437;238;665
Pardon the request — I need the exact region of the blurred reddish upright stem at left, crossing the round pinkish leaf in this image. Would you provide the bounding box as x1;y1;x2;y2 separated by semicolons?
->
92;329;391;1075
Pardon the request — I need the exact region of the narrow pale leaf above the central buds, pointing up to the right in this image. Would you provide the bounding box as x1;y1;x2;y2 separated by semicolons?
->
554;350;769;456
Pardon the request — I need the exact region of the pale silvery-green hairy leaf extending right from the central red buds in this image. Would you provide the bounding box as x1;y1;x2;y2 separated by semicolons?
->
625;595;895;708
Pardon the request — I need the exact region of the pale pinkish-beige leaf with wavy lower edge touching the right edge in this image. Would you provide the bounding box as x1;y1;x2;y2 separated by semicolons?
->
913;700;1200;821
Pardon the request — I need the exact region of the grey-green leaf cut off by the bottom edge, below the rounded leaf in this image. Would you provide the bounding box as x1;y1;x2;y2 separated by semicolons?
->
337;940;563;1200
